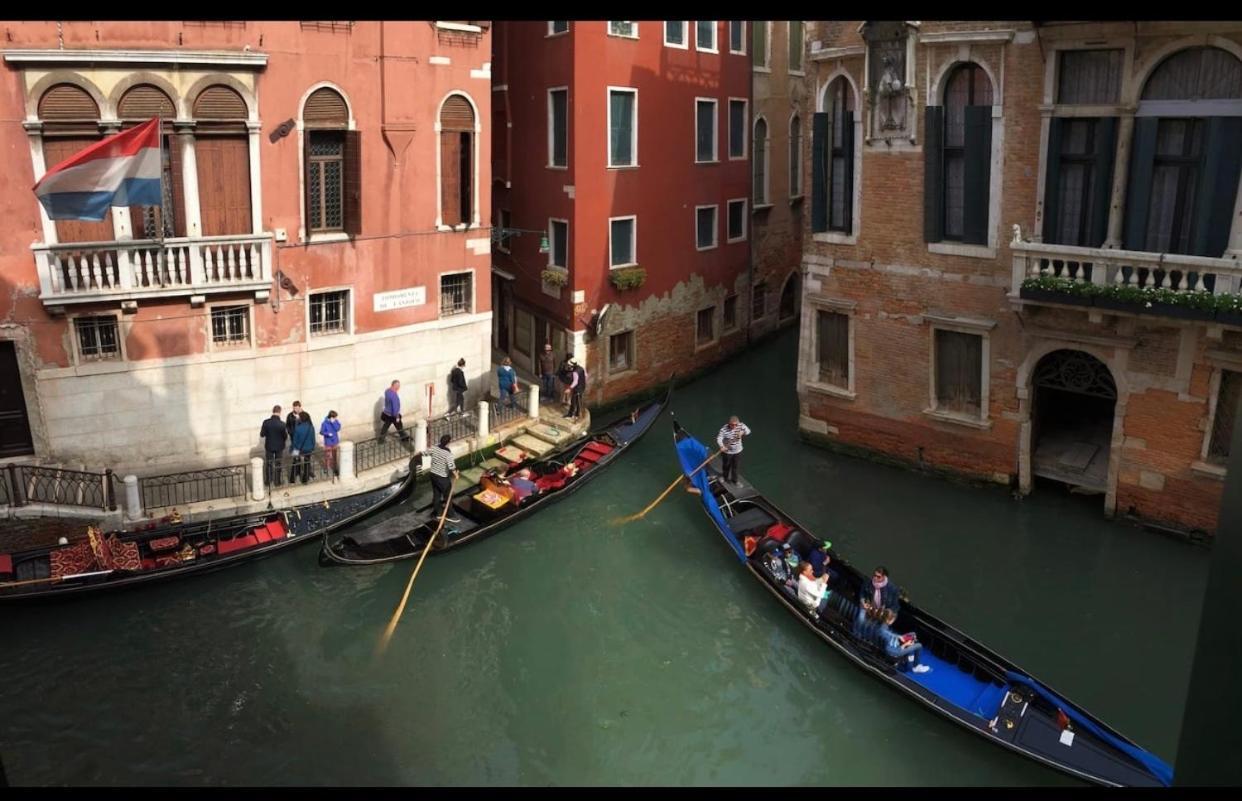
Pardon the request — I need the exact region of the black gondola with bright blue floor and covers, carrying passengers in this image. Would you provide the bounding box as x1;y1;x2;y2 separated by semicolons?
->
673;420;1172;786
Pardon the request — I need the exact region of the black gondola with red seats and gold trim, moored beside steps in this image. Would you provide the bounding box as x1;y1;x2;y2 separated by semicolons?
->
319;387;673;565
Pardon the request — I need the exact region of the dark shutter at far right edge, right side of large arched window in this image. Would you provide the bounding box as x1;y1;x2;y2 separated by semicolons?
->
1191;117;1242;258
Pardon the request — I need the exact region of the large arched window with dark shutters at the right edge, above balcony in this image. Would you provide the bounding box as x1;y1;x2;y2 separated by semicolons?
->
1123;47;1242;257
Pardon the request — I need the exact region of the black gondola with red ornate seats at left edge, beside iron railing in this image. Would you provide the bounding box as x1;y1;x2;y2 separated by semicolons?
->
0;459;415;601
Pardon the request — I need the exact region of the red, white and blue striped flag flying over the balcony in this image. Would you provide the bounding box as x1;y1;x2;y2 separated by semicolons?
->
35;118;163;222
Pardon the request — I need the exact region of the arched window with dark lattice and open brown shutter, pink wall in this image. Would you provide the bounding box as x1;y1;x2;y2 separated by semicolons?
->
302;87;361;235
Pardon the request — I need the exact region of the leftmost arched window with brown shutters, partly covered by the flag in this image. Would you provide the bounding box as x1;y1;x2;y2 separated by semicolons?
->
39;83;117;242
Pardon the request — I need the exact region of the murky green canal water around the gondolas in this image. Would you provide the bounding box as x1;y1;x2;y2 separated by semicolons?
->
0;332;1208;785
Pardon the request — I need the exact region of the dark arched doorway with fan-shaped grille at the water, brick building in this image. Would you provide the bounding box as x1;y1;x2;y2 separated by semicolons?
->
1031;350;1117;493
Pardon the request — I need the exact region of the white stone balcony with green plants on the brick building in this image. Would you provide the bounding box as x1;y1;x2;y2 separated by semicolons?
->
1010;240;1242;327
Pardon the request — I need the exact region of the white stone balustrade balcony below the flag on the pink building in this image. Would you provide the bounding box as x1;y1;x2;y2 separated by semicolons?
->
31;233;272;307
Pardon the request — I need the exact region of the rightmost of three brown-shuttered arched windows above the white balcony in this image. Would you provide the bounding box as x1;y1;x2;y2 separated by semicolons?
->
194;84;253;236
